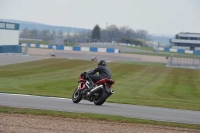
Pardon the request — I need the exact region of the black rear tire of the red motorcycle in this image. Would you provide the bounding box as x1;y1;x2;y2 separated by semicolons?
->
94;89;109;105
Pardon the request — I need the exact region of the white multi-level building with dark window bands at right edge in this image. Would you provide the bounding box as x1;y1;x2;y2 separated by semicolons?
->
170;32;200;50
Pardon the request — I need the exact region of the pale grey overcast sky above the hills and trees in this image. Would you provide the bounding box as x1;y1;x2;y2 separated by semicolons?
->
0;0;200;35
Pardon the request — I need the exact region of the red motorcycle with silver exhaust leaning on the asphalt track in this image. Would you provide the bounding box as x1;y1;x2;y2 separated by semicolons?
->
72;70;115;105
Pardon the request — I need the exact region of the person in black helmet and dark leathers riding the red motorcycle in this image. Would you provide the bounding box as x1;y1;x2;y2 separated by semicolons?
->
89;60;112;85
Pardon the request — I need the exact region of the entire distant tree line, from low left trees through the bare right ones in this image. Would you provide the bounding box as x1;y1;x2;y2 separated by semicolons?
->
20;25;150;45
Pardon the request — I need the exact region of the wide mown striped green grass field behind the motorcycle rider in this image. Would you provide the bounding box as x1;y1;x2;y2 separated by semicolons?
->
0;58;200;111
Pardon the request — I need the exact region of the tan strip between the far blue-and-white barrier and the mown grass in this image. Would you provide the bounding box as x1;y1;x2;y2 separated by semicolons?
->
25;48;167;63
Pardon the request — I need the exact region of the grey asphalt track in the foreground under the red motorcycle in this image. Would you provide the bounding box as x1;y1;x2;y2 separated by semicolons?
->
0;93;200;125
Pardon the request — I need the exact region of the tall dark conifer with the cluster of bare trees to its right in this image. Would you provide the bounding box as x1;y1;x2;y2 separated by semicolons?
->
91;25;151;45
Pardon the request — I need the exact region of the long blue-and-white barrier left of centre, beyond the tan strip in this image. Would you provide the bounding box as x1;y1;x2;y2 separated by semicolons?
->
20;43;120;53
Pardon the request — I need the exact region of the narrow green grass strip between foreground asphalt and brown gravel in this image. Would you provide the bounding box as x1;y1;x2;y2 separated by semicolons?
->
0;106;200;130
